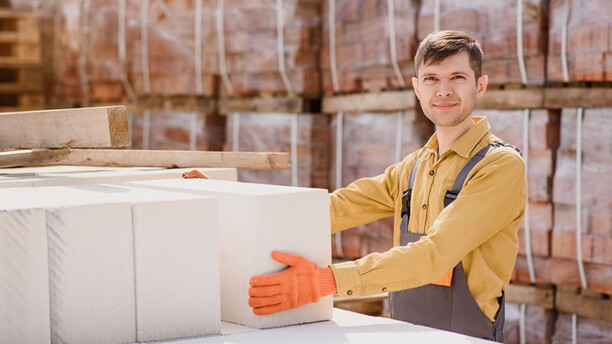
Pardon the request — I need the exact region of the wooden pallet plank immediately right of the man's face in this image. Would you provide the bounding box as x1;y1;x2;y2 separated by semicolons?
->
476;88;544;110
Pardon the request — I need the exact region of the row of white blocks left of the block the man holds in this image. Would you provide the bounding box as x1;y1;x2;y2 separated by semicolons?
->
0;185;221;343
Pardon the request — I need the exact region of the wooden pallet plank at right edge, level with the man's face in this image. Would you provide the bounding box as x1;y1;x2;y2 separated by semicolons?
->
544;87;612;109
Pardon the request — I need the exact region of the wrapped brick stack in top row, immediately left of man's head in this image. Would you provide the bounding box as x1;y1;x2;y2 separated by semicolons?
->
320;0;418;94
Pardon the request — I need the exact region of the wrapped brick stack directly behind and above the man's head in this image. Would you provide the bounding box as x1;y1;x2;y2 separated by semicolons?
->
417;0;548;85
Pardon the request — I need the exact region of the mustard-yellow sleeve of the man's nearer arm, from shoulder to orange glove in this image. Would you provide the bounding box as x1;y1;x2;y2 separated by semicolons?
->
332;149;526;296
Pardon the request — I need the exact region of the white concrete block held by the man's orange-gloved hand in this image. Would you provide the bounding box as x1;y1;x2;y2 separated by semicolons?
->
129;179;333;328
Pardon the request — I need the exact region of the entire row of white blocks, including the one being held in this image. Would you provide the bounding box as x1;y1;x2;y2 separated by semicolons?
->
0;174;332;343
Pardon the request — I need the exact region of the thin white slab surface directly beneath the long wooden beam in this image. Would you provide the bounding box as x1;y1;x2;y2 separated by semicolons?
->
0;166;237;188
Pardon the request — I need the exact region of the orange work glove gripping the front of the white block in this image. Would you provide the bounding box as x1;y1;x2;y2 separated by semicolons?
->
249;251;337;315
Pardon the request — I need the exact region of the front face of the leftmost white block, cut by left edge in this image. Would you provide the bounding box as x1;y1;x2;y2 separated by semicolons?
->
0;208;50;344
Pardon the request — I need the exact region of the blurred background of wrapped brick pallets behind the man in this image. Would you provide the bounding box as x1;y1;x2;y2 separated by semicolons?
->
0;0;612;343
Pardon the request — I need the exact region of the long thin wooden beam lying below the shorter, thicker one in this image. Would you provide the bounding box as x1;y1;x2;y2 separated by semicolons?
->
0;149;290;170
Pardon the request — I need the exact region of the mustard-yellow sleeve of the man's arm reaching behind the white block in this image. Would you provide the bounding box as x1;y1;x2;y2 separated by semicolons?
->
329;153;416;233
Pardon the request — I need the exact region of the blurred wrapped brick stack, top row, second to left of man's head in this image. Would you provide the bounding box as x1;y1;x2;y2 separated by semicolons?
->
215;0;321;96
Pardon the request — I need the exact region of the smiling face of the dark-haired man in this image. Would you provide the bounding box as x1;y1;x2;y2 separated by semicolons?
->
412;52;488;128
